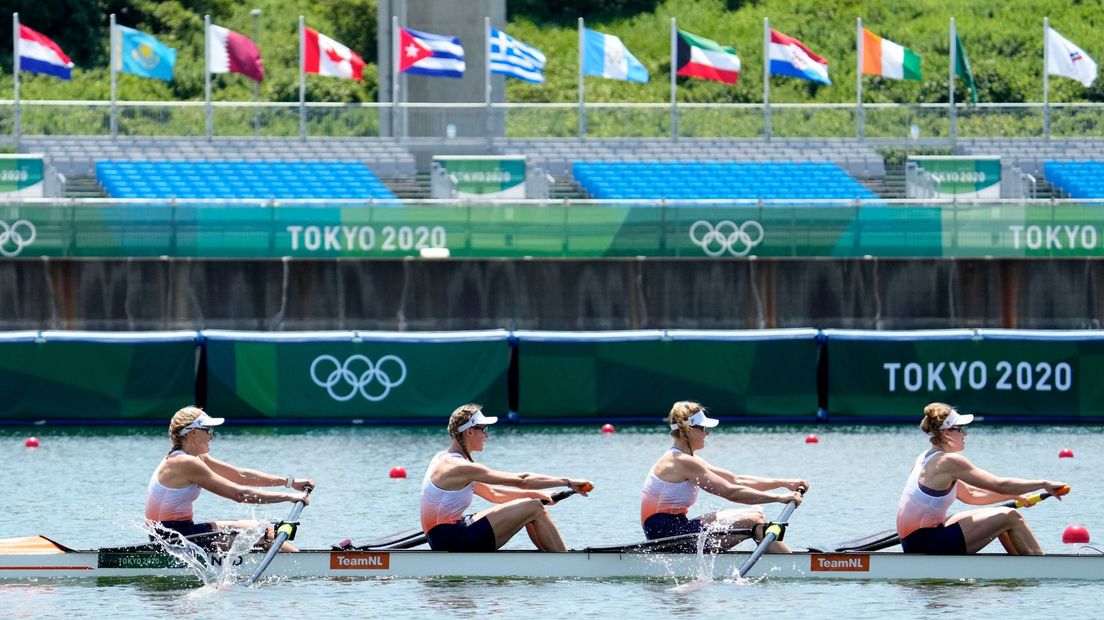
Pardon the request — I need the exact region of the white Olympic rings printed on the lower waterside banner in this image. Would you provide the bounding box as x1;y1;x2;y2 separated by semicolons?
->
310;354;406;403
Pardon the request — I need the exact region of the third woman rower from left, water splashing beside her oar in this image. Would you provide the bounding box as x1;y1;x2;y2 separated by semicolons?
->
640;400;809;553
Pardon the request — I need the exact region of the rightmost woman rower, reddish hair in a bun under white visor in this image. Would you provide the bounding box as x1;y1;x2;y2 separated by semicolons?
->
896;403;1064;555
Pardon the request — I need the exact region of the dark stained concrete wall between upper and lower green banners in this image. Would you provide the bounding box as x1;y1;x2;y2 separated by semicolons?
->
0;259;1104;330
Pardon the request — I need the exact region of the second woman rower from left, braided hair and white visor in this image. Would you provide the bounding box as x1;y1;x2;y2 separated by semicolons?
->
422;405;593;552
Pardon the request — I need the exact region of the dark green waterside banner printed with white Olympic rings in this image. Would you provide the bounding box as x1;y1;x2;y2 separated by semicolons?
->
203;331;510;424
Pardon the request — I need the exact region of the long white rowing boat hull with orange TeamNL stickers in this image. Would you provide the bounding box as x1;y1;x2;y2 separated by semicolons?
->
0;536;1104;581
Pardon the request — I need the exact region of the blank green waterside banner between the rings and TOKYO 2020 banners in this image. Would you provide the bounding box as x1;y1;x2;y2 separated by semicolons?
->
516;330;819;424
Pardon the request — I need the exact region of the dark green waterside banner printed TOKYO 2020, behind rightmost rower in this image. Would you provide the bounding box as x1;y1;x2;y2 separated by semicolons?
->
825;330;1104;417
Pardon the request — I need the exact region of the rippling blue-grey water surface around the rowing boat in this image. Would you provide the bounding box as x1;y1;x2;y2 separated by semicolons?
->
0;424;1104;618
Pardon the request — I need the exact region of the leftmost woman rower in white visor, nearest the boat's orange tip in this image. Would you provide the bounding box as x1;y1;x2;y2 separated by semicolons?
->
146;407;315;550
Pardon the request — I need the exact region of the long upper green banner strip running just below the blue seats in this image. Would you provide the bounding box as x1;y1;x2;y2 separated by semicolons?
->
10;204;1104;259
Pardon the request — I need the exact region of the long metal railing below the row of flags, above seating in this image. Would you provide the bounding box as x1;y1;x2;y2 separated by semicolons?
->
0;99;1104;140
